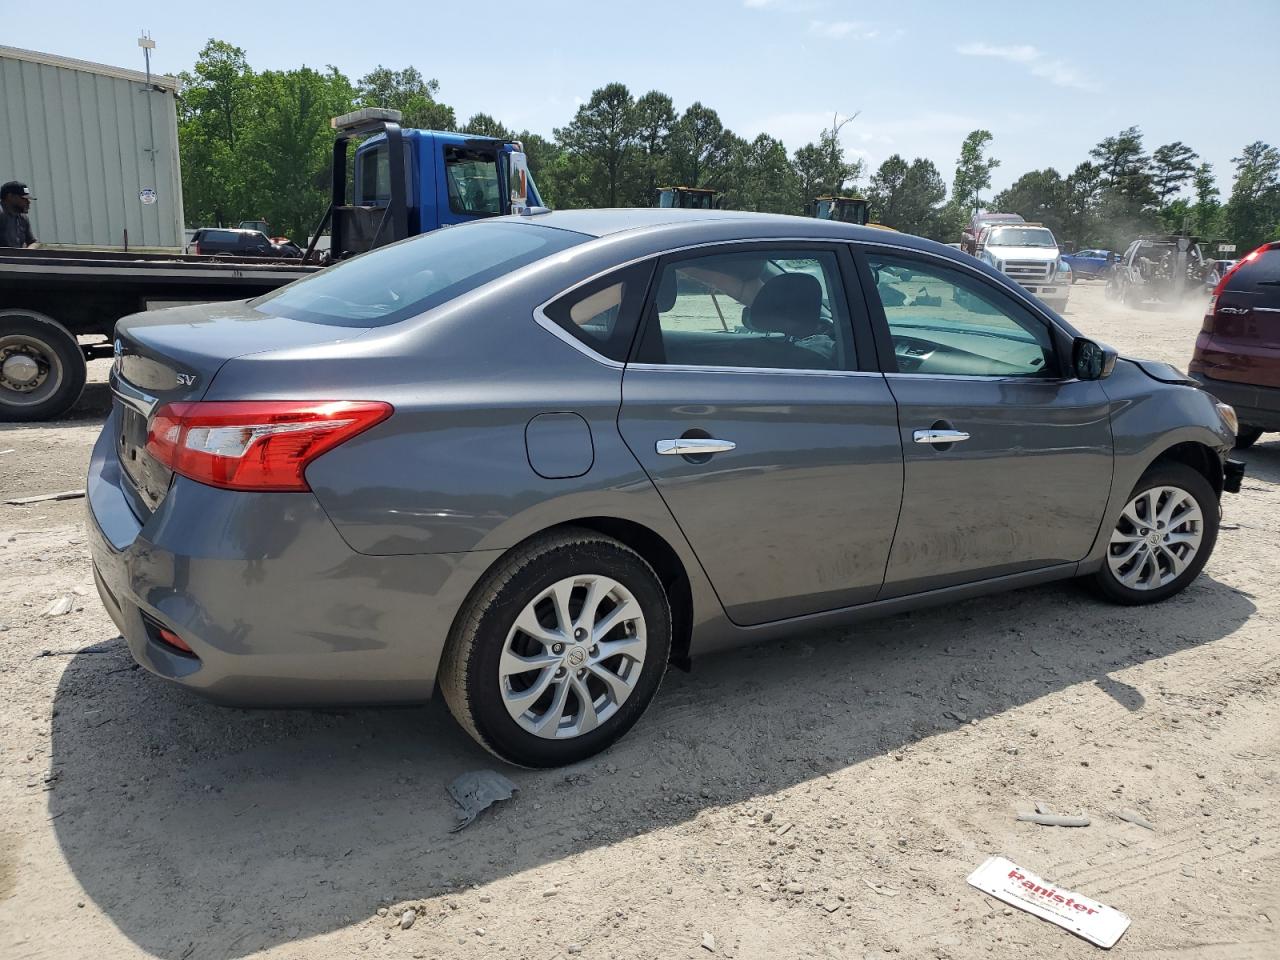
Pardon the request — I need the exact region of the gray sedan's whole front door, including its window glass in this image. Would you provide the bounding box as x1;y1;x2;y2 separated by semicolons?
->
863;244;1112;599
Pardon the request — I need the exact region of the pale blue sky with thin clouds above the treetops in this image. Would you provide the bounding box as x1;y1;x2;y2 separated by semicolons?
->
12;0;1280;198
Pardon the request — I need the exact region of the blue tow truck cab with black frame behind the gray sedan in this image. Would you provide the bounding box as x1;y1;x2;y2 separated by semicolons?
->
317;109;541;260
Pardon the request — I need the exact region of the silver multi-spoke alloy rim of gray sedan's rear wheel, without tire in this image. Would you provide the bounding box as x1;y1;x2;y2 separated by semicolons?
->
498;575;648;740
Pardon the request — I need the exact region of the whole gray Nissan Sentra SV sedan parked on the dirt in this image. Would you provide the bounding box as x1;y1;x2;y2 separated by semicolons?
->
88;210;1242;765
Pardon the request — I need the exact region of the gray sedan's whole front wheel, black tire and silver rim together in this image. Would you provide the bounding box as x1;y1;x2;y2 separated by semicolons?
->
1093;463;1219;604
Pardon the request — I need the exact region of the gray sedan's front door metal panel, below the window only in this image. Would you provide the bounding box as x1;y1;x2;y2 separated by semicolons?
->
882;375;1111;598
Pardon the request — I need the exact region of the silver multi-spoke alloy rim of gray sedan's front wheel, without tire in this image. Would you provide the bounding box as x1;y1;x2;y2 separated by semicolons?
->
1107;486;1204;590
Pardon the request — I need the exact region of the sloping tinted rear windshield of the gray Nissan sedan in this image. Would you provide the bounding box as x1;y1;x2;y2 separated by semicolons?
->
250;223;590;326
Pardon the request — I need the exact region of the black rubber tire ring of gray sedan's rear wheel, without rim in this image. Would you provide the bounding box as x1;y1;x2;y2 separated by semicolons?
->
439;529;671;767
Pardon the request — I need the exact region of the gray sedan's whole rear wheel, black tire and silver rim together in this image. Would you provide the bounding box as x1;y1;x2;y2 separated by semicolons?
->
440;530;671;767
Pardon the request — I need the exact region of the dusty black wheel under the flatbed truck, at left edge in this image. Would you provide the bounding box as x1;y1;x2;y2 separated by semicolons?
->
0;310;88;422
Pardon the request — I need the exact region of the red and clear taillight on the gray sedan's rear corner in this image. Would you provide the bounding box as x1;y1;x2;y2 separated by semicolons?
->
147;401;392;490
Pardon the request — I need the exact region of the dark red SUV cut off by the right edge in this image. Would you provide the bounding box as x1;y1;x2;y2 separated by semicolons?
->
1189;241;1280;448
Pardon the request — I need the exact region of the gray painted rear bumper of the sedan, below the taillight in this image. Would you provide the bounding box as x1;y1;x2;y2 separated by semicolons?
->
86;415;493;707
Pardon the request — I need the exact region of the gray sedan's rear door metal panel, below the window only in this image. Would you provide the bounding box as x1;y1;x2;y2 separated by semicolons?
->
618;364;902;625
